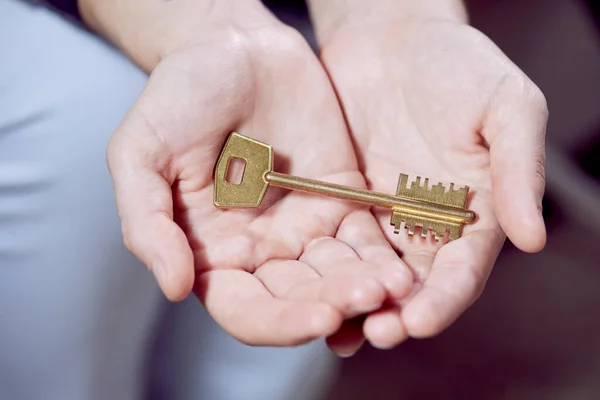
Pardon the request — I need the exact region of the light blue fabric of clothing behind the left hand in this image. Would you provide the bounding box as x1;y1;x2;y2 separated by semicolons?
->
0;0;337;400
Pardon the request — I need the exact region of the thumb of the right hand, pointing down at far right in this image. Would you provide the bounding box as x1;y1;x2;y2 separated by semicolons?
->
482;78;548;252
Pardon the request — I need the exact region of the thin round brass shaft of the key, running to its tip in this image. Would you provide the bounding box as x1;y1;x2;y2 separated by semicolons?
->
264;171;475;224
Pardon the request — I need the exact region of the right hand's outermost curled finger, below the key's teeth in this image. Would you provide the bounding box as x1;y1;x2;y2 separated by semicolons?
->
402;229;504;337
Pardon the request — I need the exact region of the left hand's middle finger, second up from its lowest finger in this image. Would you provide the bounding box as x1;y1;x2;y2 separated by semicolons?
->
254;261;385;319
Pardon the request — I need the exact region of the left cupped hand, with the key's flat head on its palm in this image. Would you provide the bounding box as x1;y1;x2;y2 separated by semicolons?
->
108;18;413;354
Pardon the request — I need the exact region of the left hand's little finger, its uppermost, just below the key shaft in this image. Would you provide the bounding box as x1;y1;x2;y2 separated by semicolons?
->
336;209;413;299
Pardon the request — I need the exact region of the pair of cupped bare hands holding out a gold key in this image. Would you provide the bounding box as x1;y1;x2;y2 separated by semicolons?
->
108;2;547;356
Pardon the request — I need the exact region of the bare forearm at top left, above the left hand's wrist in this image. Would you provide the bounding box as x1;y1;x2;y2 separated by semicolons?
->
78;0;269;72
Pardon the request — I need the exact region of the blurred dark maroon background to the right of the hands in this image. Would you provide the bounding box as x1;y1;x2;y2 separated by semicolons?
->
265;0;600;400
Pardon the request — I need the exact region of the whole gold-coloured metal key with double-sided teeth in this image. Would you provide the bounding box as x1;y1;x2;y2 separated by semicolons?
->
214;132;475;240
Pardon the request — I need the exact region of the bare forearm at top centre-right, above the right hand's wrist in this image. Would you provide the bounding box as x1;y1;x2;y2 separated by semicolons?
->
308;0;468;41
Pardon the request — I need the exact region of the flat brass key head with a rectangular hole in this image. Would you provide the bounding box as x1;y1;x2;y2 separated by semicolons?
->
214;132;273;208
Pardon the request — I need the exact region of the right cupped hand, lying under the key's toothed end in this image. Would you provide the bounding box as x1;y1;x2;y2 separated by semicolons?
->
321;17;547;348
